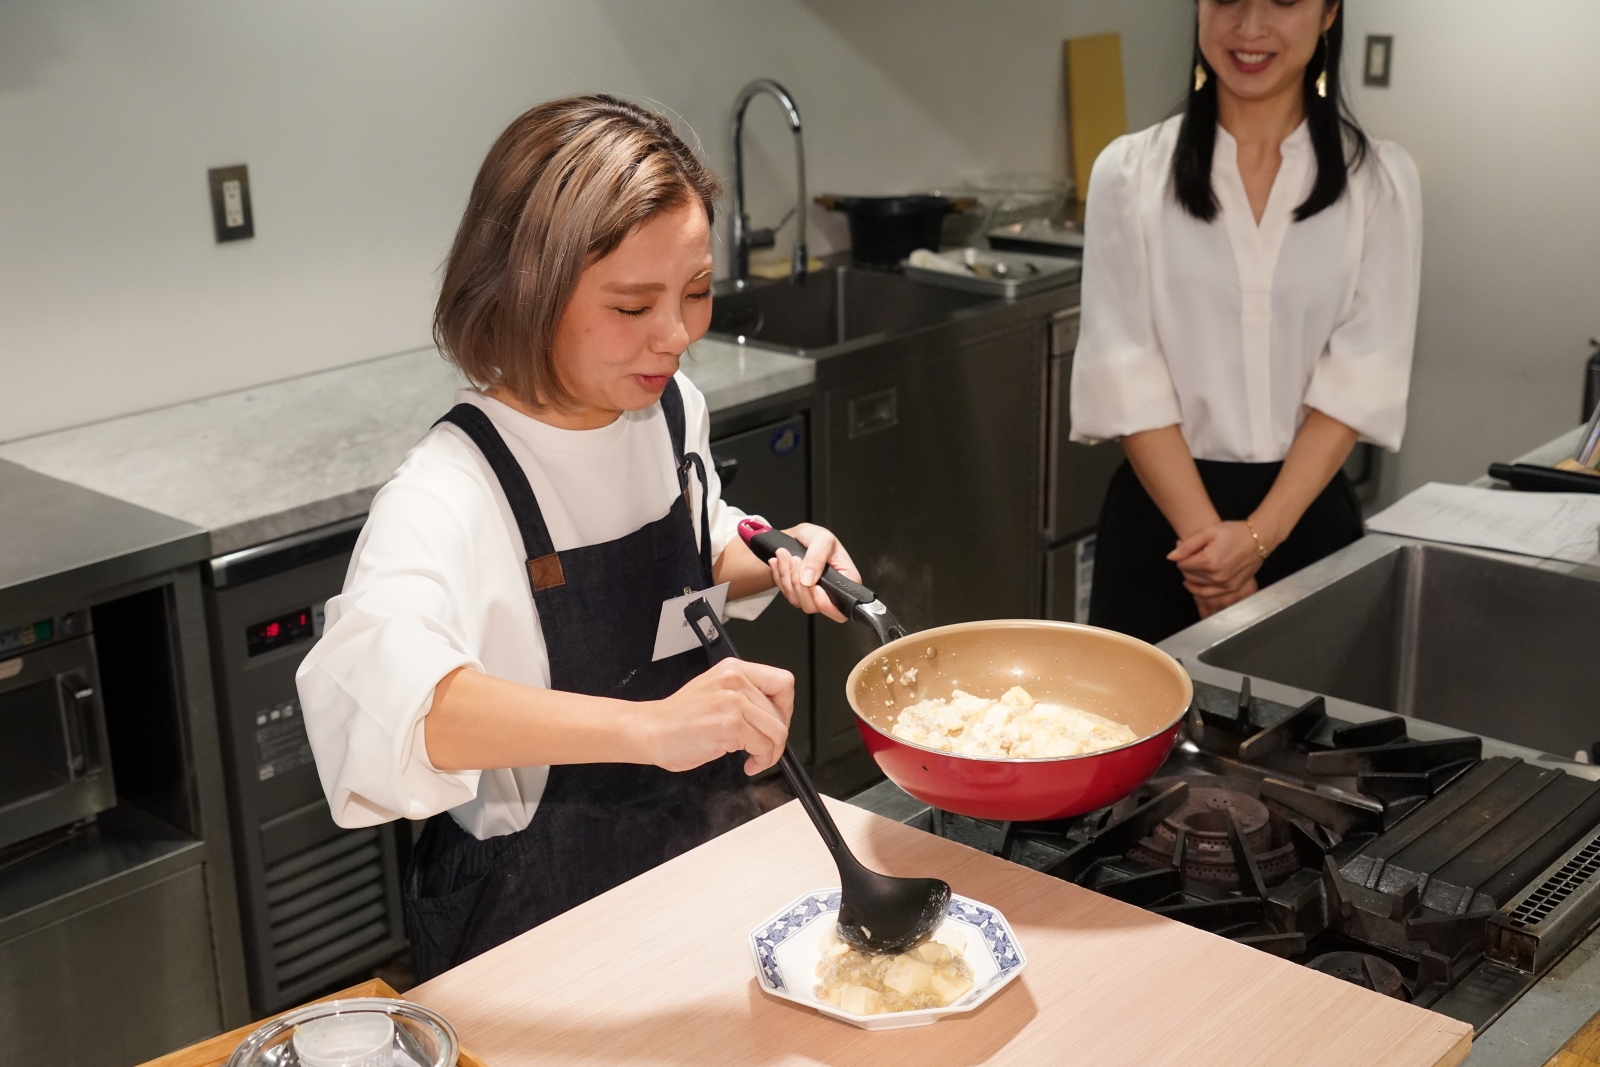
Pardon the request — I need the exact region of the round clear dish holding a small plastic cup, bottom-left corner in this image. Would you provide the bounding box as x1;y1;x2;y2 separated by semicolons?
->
227;997;461;1067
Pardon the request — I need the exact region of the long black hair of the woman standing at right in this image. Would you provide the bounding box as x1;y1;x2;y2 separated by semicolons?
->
1173;0;1371;222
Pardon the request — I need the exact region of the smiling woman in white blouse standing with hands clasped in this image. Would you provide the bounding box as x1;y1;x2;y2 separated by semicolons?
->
1072;0;1421;641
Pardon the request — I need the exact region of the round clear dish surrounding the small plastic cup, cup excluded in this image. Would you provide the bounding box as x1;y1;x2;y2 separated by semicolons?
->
227;997;461;1067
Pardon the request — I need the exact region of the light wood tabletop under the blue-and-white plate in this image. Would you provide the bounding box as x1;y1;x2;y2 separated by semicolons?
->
410;801;1472;1067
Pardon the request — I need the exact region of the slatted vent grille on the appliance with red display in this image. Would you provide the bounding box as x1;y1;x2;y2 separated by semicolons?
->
266;829;390;985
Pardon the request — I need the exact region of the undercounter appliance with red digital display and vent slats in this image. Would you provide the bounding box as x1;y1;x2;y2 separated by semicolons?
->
205;515;411;1017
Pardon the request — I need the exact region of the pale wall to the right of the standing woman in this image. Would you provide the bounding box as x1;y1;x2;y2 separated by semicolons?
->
1346;0;1600;491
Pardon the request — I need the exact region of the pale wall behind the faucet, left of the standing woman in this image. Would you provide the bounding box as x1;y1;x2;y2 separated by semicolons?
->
0;0;1190;440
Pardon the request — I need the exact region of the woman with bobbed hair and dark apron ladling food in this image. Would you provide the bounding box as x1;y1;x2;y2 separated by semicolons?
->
298;96;854;979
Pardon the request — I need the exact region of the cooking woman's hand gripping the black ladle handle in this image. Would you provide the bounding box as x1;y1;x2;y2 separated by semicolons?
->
638;659;795;774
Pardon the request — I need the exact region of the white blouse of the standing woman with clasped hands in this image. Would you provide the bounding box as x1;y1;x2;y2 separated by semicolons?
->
1072;117;1422;462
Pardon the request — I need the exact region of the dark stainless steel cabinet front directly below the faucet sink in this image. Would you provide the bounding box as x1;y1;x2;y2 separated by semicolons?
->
816;320;1046;761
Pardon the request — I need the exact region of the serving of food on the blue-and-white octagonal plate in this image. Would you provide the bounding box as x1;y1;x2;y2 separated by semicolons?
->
816;921;973;1016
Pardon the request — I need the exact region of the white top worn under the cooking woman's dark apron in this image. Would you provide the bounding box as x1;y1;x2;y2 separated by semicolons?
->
294;373;776;840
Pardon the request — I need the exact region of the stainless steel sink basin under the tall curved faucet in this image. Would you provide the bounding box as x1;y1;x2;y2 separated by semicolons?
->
710;266;995;352
